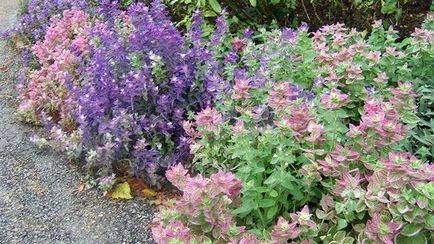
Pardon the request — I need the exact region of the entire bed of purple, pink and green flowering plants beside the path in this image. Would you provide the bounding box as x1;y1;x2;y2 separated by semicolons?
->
5;0;434;243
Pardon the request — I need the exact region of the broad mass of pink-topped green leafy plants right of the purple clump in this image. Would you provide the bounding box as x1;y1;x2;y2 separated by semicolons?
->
154;15;434;243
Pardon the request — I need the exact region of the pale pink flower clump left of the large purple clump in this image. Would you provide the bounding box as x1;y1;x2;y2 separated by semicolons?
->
18;8;92;131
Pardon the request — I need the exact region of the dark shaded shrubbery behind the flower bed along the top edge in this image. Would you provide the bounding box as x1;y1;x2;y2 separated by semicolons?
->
164;0;432;36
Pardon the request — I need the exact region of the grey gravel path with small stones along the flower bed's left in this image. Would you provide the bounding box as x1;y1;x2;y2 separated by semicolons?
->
0;0;154;244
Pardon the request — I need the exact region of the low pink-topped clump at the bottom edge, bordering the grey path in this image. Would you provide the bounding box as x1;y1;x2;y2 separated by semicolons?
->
152;164;248;243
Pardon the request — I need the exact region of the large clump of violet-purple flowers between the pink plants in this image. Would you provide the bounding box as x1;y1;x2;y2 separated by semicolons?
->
63;1;229;186
